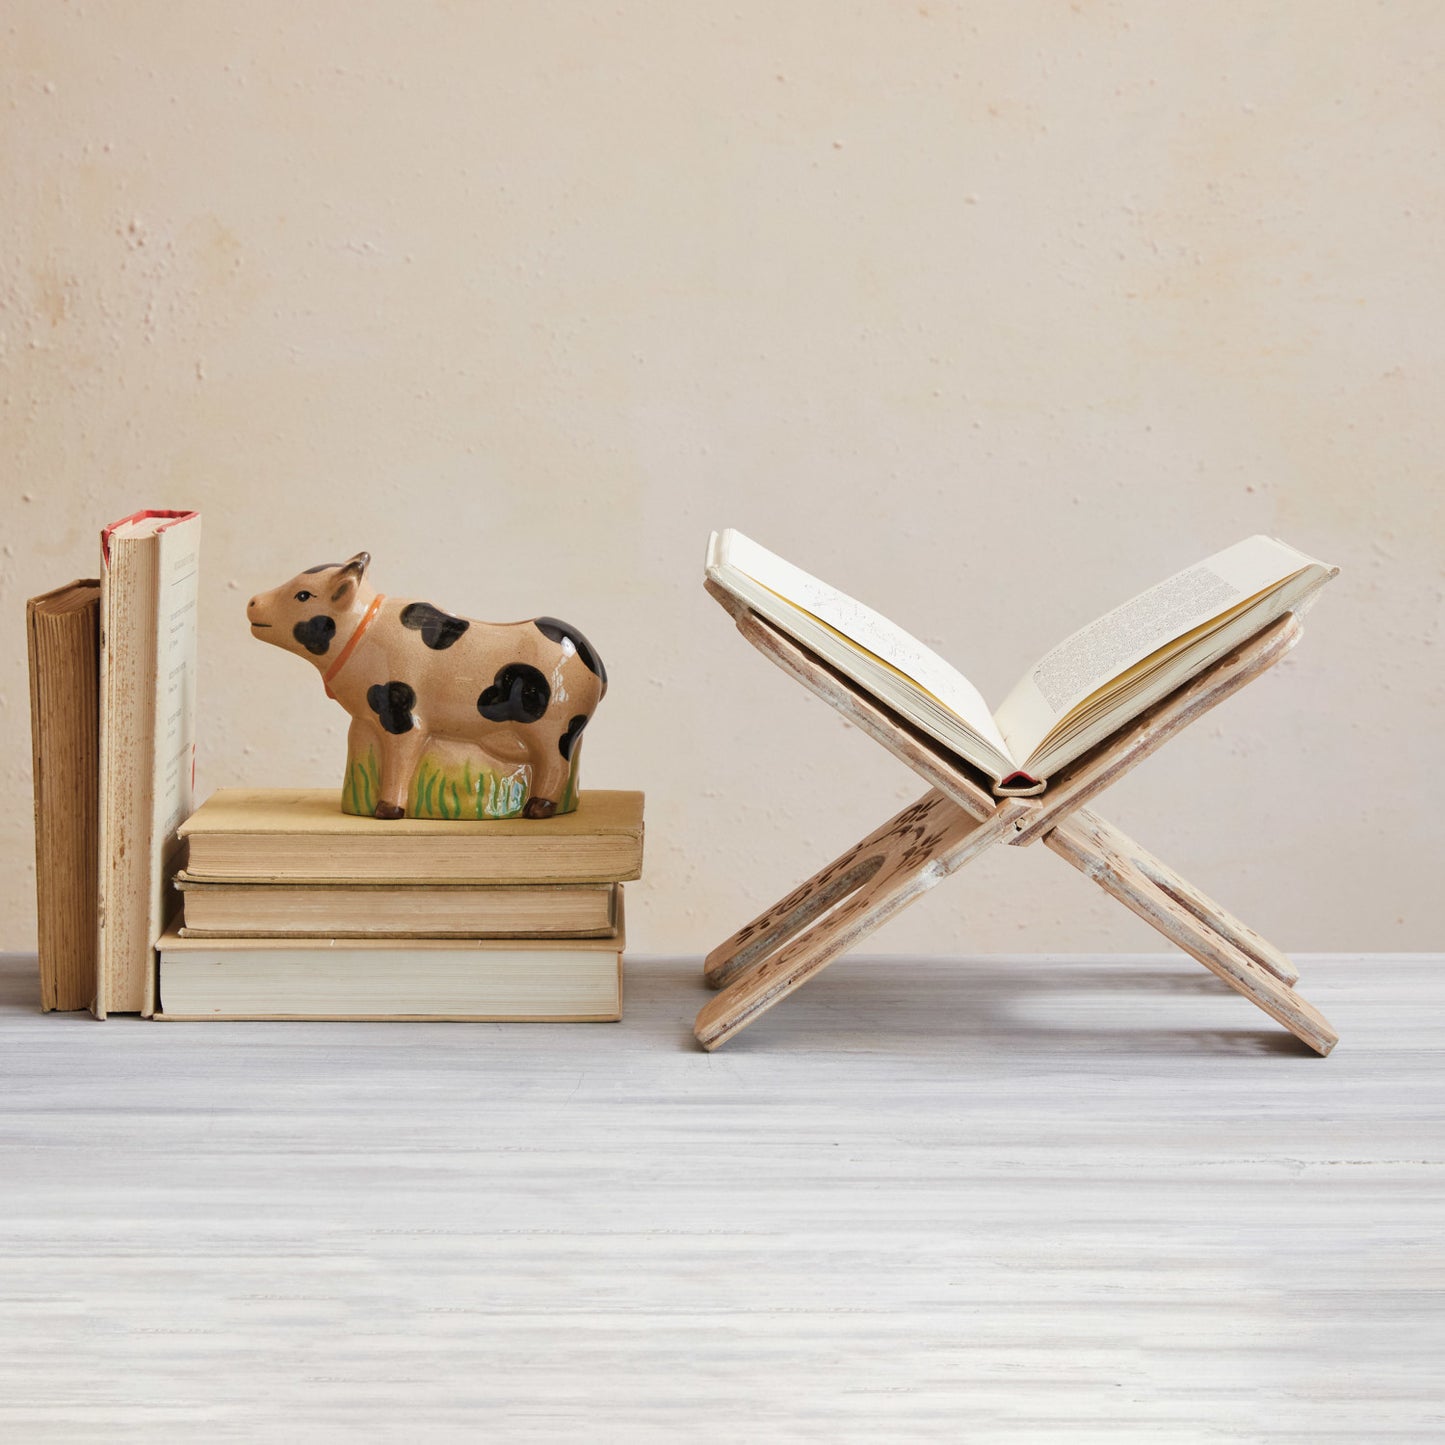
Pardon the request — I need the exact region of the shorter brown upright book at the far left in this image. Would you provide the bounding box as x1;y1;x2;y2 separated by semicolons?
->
25;579;100;1010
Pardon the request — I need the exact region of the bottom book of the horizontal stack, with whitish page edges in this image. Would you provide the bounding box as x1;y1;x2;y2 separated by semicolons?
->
156;895;626;1023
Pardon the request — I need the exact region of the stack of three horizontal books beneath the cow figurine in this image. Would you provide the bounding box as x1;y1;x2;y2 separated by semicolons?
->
156;789;643;1022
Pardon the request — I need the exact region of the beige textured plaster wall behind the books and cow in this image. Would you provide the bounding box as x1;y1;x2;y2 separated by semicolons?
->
0;0;1445;954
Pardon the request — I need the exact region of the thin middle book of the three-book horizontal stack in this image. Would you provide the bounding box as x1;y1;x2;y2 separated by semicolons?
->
176;871;618;938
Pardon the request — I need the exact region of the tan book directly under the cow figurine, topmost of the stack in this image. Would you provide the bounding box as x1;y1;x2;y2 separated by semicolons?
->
181;788;643;883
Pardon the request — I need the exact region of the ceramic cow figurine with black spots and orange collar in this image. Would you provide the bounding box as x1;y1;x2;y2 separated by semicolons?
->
246;552;607;818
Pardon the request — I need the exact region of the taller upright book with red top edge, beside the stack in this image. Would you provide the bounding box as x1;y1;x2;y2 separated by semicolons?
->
95;512;201;1017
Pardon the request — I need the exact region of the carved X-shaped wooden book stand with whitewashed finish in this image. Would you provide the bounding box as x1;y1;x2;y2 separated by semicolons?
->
695;582;1338;1053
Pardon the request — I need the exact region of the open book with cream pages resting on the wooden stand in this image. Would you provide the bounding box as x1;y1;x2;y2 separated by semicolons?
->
707;529;1338;793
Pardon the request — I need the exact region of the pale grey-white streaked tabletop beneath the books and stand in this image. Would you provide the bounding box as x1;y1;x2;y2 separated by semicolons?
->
0;955;1445;1442
